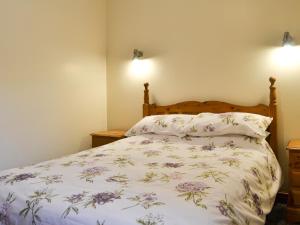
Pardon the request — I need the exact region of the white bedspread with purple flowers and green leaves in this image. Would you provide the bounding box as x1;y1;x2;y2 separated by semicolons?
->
0;135;281;225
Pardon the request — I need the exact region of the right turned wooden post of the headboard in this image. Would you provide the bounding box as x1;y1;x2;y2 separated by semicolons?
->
269;77;278;156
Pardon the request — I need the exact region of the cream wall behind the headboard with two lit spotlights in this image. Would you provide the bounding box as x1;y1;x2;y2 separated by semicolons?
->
107;0;300;190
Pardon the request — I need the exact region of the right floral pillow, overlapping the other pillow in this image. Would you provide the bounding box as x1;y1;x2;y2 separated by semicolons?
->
183;112;272;138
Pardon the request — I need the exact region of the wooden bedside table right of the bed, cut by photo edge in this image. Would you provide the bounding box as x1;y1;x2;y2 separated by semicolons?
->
286;140;300;223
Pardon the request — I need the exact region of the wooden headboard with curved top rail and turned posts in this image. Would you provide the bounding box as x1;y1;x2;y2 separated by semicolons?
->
143;77;278;156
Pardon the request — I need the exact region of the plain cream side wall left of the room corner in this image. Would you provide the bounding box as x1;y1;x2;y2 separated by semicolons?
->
0;0;107;169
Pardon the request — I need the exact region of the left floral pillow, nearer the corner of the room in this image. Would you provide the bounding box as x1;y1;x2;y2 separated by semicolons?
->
125;114;195;137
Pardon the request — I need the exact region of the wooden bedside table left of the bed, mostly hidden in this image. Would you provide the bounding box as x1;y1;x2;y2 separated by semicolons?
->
91;130;126;148
